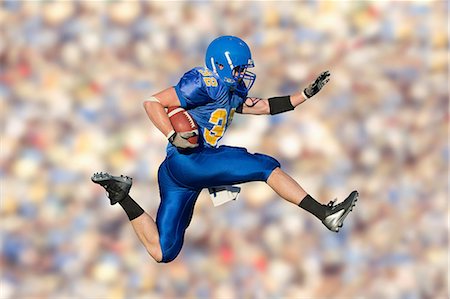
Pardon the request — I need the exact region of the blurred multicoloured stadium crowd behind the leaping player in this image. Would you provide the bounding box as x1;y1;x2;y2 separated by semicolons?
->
0;1;449;299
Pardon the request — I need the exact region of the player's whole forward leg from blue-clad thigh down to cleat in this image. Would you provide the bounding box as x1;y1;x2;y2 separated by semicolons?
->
165;146;358;232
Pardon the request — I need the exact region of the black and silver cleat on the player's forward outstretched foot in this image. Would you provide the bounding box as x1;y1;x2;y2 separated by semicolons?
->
322;191;359;233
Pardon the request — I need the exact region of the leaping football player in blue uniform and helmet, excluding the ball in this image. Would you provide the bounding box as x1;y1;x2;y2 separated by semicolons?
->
92;36;358;263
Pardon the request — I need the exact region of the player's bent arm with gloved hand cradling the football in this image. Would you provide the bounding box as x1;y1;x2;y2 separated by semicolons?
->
144;87;198;148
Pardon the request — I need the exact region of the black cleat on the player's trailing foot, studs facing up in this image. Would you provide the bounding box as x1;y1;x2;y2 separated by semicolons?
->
91;172;133;205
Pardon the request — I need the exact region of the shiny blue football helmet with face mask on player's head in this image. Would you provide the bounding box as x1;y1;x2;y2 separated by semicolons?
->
205;35;256;93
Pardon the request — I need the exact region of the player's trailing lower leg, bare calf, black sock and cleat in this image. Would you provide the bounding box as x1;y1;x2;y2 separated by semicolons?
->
91;173;162;262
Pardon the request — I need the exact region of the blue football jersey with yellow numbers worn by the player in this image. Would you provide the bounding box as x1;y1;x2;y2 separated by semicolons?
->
168;67;247;150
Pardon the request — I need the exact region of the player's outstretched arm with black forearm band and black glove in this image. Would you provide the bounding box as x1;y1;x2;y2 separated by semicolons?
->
236;71;330;115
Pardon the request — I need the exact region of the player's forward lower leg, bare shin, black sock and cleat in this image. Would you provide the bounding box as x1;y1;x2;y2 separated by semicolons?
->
267;168;358;232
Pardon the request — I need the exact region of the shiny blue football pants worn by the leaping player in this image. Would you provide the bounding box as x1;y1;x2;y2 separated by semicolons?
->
156;146;280;263
